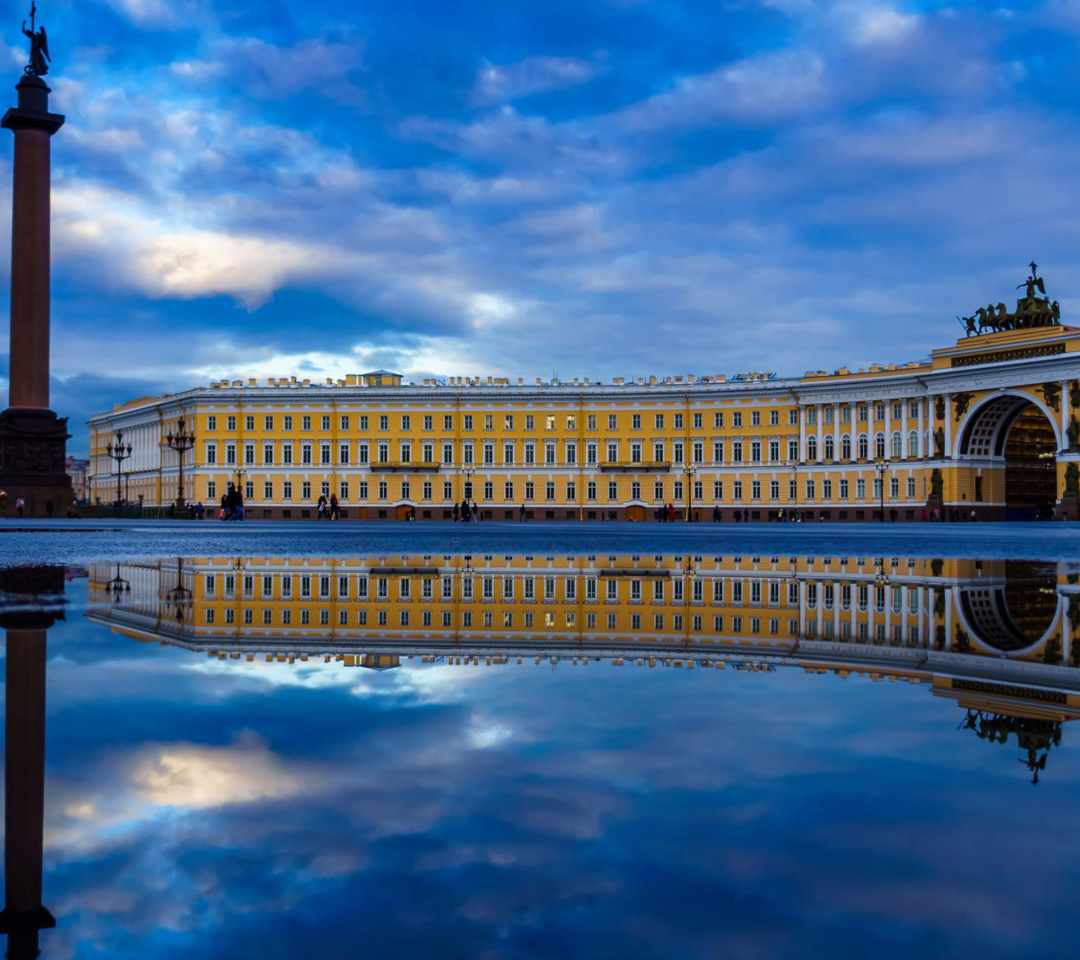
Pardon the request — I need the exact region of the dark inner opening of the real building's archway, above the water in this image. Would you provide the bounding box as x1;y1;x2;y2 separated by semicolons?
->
1004;404;1057;520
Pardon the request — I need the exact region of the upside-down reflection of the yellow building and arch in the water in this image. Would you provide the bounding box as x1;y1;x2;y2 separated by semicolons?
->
90;556;1080;773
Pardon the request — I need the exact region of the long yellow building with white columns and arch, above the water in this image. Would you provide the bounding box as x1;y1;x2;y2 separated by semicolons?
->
90;278;1080;522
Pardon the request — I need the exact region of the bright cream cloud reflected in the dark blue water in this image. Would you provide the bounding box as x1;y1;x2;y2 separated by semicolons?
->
132;733;306;810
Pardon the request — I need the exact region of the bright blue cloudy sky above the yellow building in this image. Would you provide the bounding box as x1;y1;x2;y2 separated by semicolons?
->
0;0;1080;447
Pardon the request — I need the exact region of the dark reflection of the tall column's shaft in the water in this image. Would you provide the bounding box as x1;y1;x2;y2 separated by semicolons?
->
0;618;56;960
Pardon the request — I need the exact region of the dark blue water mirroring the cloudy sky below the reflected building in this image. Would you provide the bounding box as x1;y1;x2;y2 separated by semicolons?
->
2;525;1080;960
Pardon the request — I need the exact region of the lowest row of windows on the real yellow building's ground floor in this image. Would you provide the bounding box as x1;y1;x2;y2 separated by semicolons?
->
206;476;917;503
